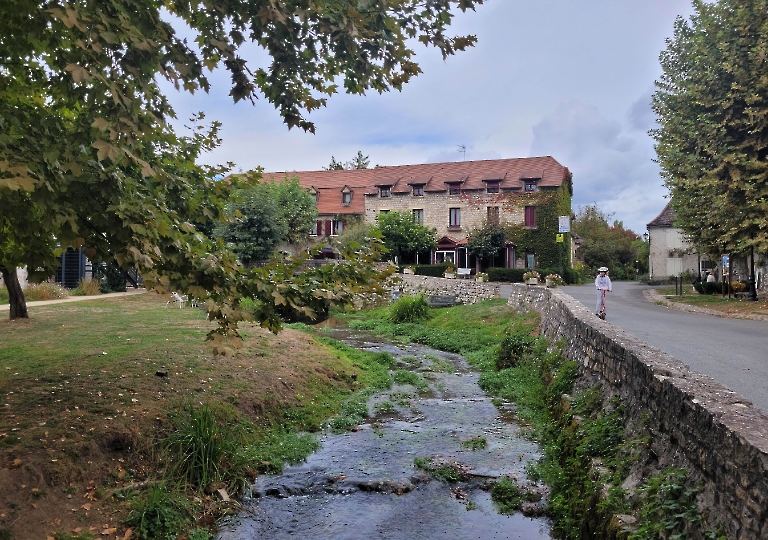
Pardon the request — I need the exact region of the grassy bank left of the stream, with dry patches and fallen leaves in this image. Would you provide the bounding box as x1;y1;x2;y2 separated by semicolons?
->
0;294;388;540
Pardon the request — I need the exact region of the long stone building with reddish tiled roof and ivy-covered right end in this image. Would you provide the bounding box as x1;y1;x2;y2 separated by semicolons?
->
264;156;573;268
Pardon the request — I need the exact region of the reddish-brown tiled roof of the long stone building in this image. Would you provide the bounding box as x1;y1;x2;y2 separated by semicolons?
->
264;156;569;214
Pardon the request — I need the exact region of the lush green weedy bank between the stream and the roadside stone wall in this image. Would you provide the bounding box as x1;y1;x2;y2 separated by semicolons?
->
336;299;715;539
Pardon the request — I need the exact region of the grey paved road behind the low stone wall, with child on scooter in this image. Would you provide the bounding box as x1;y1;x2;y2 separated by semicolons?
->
561;282;768;412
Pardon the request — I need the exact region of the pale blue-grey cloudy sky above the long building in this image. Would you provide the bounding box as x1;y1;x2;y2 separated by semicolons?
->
166;0;692;234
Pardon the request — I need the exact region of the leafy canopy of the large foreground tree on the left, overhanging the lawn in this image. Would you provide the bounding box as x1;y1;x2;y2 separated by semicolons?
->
0;0;482;335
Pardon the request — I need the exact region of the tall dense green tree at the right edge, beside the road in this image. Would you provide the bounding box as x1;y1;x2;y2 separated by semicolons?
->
653;0;768;252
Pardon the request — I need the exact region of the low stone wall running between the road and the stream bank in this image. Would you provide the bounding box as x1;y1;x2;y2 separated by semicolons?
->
509;284;768;540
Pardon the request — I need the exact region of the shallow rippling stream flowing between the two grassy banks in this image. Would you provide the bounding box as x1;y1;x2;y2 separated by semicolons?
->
217;330;551;540
